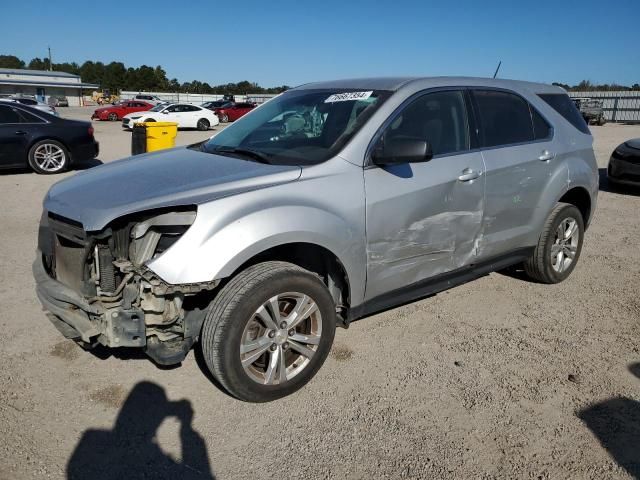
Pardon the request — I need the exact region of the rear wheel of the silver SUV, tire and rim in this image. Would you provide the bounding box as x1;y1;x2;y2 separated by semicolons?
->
524;203;584;283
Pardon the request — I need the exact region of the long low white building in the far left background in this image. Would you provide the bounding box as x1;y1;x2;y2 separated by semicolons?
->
0;68;98;107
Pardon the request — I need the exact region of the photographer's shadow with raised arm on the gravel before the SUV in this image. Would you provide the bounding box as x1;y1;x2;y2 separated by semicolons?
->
67;382;215;480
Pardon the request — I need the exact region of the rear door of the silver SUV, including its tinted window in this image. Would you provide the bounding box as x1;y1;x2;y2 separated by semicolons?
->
472;89;555;258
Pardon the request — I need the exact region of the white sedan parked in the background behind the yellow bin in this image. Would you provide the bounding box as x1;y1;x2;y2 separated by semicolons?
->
122;103;220;131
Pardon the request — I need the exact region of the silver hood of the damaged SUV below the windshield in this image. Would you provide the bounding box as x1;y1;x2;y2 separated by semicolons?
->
44;147;302;231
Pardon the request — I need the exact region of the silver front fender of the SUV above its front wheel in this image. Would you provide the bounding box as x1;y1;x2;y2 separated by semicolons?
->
148;162;366;303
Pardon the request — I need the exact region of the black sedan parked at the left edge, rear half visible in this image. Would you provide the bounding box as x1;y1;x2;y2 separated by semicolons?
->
0;102;98;174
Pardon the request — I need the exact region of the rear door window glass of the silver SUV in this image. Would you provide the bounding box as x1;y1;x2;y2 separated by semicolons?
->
473;90;534;147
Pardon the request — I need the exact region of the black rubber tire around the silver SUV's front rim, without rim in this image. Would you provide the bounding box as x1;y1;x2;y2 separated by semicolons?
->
201;261;336;402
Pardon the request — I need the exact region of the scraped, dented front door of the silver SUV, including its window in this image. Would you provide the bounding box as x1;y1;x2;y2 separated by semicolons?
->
364;90;484;300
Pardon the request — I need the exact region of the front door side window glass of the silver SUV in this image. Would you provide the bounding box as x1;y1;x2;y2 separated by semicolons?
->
384;91;469;155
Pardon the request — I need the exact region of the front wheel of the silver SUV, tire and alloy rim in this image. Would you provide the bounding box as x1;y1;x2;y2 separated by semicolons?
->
201;261;336;402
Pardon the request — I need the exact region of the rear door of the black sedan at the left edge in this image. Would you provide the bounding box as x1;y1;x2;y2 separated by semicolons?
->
0;103;30;167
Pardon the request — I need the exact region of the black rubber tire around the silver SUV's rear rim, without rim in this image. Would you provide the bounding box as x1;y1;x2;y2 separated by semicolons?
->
524;203;584;284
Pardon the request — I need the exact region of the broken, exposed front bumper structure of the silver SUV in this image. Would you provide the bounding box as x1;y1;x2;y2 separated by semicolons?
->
33;251;215;365
